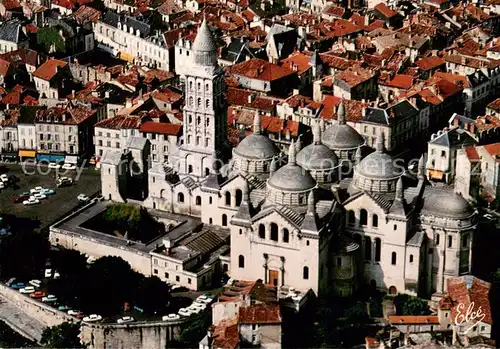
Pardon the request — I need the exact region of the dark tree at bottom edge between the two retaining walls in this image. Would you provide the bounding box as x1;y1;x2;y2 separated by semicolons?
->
40;322;85;348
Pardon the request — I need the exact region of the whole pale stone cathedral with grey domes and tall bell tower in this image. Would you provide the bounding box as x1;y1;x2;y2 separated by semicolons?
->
103;22;477;296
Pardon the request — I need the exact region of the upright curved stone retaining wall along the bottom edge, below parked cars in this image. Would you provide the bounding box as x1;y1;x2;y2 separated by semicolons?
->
80;321;182;349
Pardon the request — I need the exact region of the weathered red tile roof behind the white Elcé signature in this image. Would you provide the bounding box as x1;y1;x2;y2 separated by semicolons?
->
447;275;492;324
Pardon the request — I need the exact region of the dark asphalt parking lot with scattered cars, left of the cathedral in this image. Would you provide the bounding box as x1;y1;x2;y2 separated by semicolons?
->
0;164;101;230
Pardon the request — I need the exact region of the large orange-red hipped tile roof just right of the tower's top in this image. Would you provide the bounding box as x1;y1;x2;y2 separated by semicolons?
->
229;58;294;81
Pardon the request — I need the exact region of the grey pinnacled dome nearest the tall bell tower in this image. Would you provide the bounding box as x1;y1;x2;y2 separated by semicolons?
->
234;113;280;160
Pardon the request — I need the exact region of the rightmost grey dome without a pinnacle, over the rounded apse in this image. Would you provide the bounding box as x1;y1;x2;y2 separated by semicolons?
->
422;188;474;219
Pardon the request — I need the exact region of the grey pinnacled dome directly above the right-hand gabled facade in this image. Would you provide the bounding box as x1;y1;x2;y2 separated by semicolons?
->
355;134;403;179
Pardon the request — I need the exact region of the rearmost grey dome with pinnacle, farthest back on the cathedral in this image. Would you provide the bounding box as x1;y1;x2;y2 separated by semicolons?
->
323;101;365;150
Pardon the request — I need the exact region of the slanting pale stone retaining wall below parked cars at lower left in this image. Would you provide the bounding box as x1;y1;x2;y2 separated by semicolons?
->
0;284;78;327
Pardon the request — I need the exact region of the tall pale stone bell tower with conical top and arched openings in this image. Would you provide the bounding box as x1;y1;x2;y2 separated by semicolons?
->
178;20;228;177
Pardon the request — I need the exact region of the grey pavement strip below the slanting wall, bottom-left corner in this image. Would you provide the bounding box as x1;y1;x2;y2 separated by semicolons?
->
0;297;46;342
